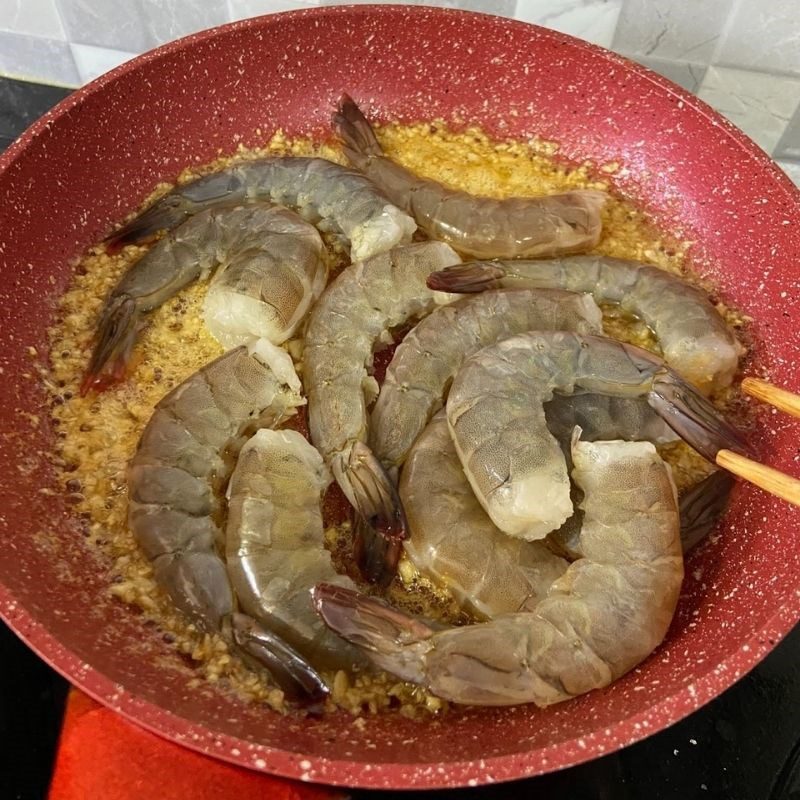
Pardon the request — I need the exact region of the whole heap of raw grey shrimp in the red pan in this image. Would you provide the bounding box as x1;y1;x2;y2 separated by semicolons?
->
64;95;746;716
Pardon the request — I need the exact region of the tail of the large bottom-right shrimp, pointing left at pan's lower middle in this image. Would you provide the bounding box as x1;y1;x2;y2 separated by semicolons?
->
311;583;435;683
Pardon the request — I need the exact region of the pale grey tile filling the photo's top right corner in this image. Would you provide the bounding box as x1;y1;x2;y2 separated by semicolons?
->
716;0;800;75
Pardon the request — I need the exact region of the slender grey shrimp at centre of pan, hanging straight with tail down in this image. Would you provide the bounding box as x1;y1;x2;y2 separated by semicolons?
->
303;242;458;580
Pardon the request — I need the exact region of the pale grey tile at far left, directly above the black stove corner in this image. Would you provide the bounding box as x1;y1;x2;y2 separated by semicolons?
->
0;31;80;86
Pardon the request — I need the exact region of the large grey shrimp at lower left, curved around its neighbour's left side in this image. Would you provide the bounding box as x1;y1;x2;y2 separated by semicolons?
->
128;339;327;701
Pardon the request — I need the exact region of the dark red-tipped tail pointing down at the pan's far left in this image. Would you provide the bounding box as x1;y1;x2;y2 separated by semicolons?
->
80;295;139;397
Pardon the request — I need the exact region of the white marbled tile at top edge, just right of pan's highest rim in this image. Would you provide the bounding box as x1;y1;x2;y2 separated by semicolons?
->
514;0;622;47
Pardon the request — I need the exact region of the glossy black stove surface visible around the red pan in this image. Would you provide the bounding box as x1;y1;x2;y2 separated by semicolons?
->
0;78;800;800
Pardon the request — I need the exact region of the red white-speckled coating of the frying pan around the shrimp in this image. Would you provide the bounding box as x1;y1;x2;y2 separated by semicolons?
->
0;6;800;787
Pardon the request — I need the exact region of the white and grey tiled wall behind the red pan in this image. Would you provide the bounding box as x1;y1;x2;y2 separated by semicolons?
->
0;0;800;169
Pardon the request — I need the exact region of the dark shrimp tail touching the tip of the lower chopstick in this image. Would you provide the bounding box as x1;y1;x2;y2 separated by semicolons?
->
647;370;755;464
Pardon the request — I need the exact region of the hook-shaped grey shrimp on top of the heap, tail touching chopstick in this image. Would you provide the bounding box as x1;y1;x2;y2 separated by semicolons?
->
447;332;747;539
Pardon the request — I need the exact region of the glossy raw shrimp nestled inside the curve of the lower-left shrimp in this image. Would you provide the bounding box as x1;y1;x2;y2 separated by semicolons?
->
225;429;363;669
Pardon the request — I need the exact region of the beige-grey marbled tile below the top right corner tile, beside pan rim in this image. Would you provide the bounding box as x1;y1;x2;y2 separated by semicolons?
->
697;67;800;153
